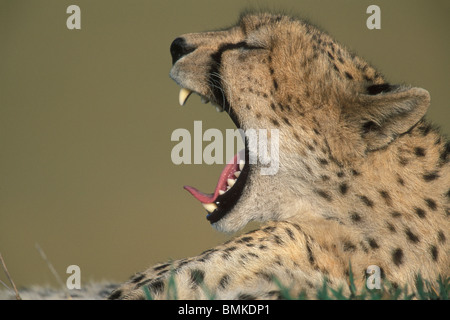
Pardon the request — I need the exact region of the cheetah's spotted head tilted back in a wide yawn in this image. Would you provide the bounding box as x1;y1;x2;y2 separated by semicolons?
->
170;14;429;232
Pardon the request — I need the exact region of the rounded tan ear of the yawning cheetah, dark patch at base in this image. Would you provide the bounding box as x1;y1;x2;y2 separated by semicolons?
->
352;84;430;151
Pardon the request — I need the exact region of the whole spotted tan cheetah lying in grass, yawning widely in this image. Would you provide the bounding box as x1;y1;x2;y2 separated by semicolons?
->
110;13;450;299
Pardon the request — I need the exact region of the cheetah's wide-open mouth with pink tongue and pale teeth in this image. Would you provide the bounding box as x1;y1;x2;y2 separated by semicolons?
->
179;88;249;223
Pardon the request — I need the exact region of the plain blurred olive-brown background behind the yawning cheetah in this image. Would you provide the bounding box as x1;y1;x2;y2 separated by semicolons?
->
0;0;450;286
